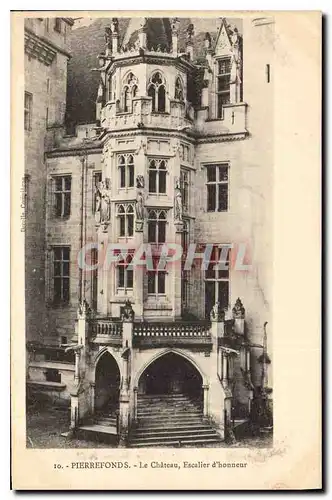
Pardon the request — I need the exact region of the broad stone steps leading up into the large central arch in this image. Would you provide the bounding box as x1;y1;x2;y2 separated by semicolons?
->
130;394;221;448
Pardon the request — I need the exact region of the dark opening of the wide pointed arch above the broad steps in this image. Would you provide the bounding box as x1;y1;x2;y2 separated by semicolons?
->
138;352;203;403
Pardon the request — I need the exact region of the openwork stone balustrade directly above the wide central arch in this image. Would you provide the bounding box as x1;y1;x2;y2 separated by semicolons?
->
133;322;211;346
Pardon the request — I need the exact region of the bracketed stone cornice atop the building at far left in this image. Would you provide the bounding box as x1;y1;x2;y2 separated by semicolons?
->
24;28;71;66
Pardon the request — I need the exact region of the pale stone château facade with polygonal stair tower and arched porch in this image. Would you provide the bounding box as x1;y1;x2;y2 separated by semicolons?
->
29;17;273;446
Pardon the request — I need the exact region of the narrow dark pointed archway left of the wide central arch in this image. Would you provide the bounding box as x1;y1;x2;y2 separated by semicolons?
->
95;351;120;412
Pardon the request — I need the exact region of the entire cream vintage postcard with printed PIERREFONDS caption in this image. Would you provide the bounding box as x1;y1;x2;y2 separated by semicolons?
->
11;11;322;490
